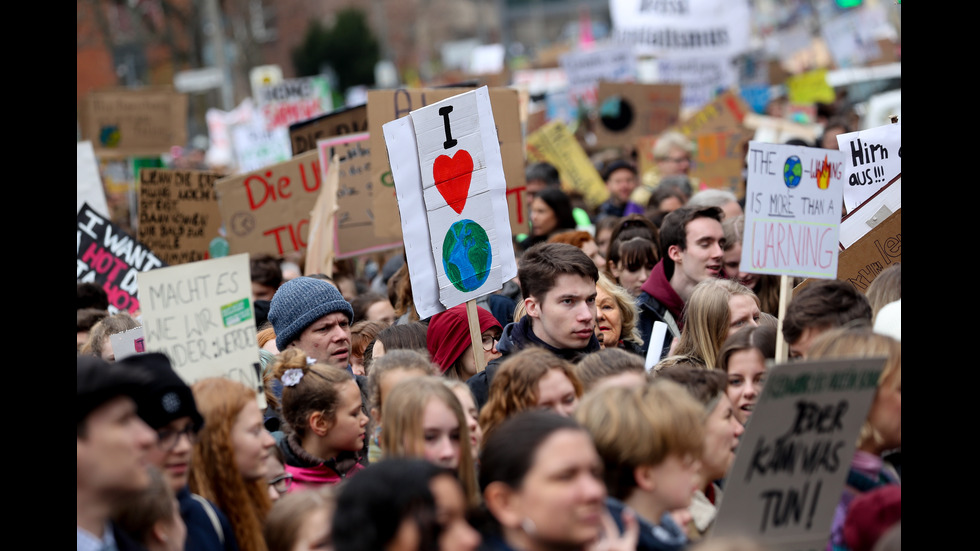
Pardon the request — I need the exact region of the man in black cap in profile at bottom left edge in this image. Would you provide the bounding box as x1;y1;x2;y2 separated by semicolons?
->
75;356;156;551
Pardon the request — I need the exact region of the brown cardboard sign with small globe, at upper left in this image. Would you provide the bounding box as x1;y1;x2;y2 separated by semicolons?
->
78;88;187;157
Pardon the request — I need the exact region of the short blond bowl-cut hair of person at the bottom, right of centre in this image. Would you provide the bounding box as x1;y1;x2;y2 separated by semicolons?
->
575;379;704;500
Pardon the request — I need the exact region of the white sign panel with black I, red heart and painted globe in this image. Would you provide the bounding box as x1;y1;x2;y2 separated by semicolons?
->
411;89;502;308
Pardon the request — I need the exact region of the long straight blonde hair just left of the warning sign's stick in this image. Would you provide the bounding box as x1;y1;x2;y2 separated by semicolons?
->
674;278;760;369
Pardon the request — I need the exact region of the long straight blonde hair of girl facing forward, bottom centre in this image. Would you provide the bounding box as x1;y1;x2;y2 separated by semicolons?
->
378;375;480;506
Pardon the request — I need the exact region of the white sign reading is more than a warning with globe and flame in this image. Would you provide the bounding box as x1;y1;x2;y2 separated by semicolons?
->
739;141;844;279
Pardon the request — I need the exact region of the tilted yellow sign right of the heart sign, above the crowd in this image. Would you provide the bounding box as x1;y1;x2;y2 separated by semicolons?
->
527;121;609;209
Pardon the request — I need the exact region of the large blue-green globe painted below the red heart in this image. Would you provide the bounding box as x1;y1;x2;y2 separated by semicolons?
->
442;219;493;292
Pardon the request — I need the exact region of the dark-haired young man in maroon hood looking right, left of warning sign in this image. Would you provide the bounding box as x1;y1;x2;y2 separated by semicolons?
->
636;205;725;358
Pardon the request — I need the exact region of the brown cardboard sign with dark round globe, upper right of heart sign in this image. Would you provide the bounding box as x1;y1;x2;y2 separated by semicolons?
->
595;81;681;147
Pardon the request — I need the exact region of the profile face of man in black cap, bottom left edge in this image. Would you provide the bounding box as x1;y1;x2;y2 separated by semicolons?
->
76;396;157;495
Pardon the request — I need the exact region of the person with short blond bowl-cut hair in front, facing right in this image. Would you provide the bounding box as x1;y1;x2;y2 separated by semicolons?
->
575;379;704;551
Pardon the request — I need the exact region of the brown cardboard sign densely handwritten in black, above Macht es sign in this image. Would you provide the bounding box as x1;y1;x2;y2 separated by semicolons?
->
138;168;224;266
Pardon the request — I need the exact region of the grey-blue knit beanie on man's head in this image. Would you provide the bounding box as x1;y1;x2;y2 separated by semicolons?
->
269;277;354;350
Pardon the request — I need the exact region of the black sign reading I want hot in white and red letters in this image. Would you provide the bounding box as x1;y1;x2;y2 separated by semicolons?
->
75;204;167;314
